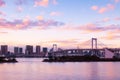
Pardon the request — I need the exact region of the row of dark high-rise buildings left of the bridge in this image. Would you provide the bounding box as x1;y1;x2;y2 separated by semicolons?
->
0;45;47;54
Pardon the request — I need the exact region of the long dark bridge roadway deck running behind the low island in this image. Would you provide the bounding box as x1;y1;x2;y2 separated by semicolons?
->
50;48;120;57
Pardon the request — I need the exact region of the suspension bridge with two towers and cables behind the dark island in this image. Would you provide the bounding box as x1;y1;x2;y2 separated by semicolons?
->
48;38;120;58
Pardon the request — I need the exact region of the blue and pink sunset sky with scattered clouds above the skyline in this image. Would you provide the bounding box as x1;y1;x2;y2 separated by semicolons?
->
0;0;120;48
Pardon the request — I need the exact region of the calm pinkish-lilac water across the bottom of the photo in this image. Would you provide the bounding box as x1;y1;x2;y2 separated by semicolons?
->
0;58;120;80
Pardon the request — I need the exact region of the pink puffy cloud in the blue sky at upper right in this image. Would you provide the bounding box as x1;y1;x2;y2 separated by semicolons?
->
91;4;115;14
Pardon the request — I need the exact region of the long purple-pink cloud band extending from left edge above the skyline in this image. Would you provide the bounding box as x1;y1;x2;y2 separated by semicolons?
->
0;18;64;30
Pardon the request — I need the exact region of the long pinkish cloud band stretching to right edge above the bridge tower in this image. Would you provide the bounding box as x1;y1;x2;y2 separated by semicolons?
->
56;19;120;33
